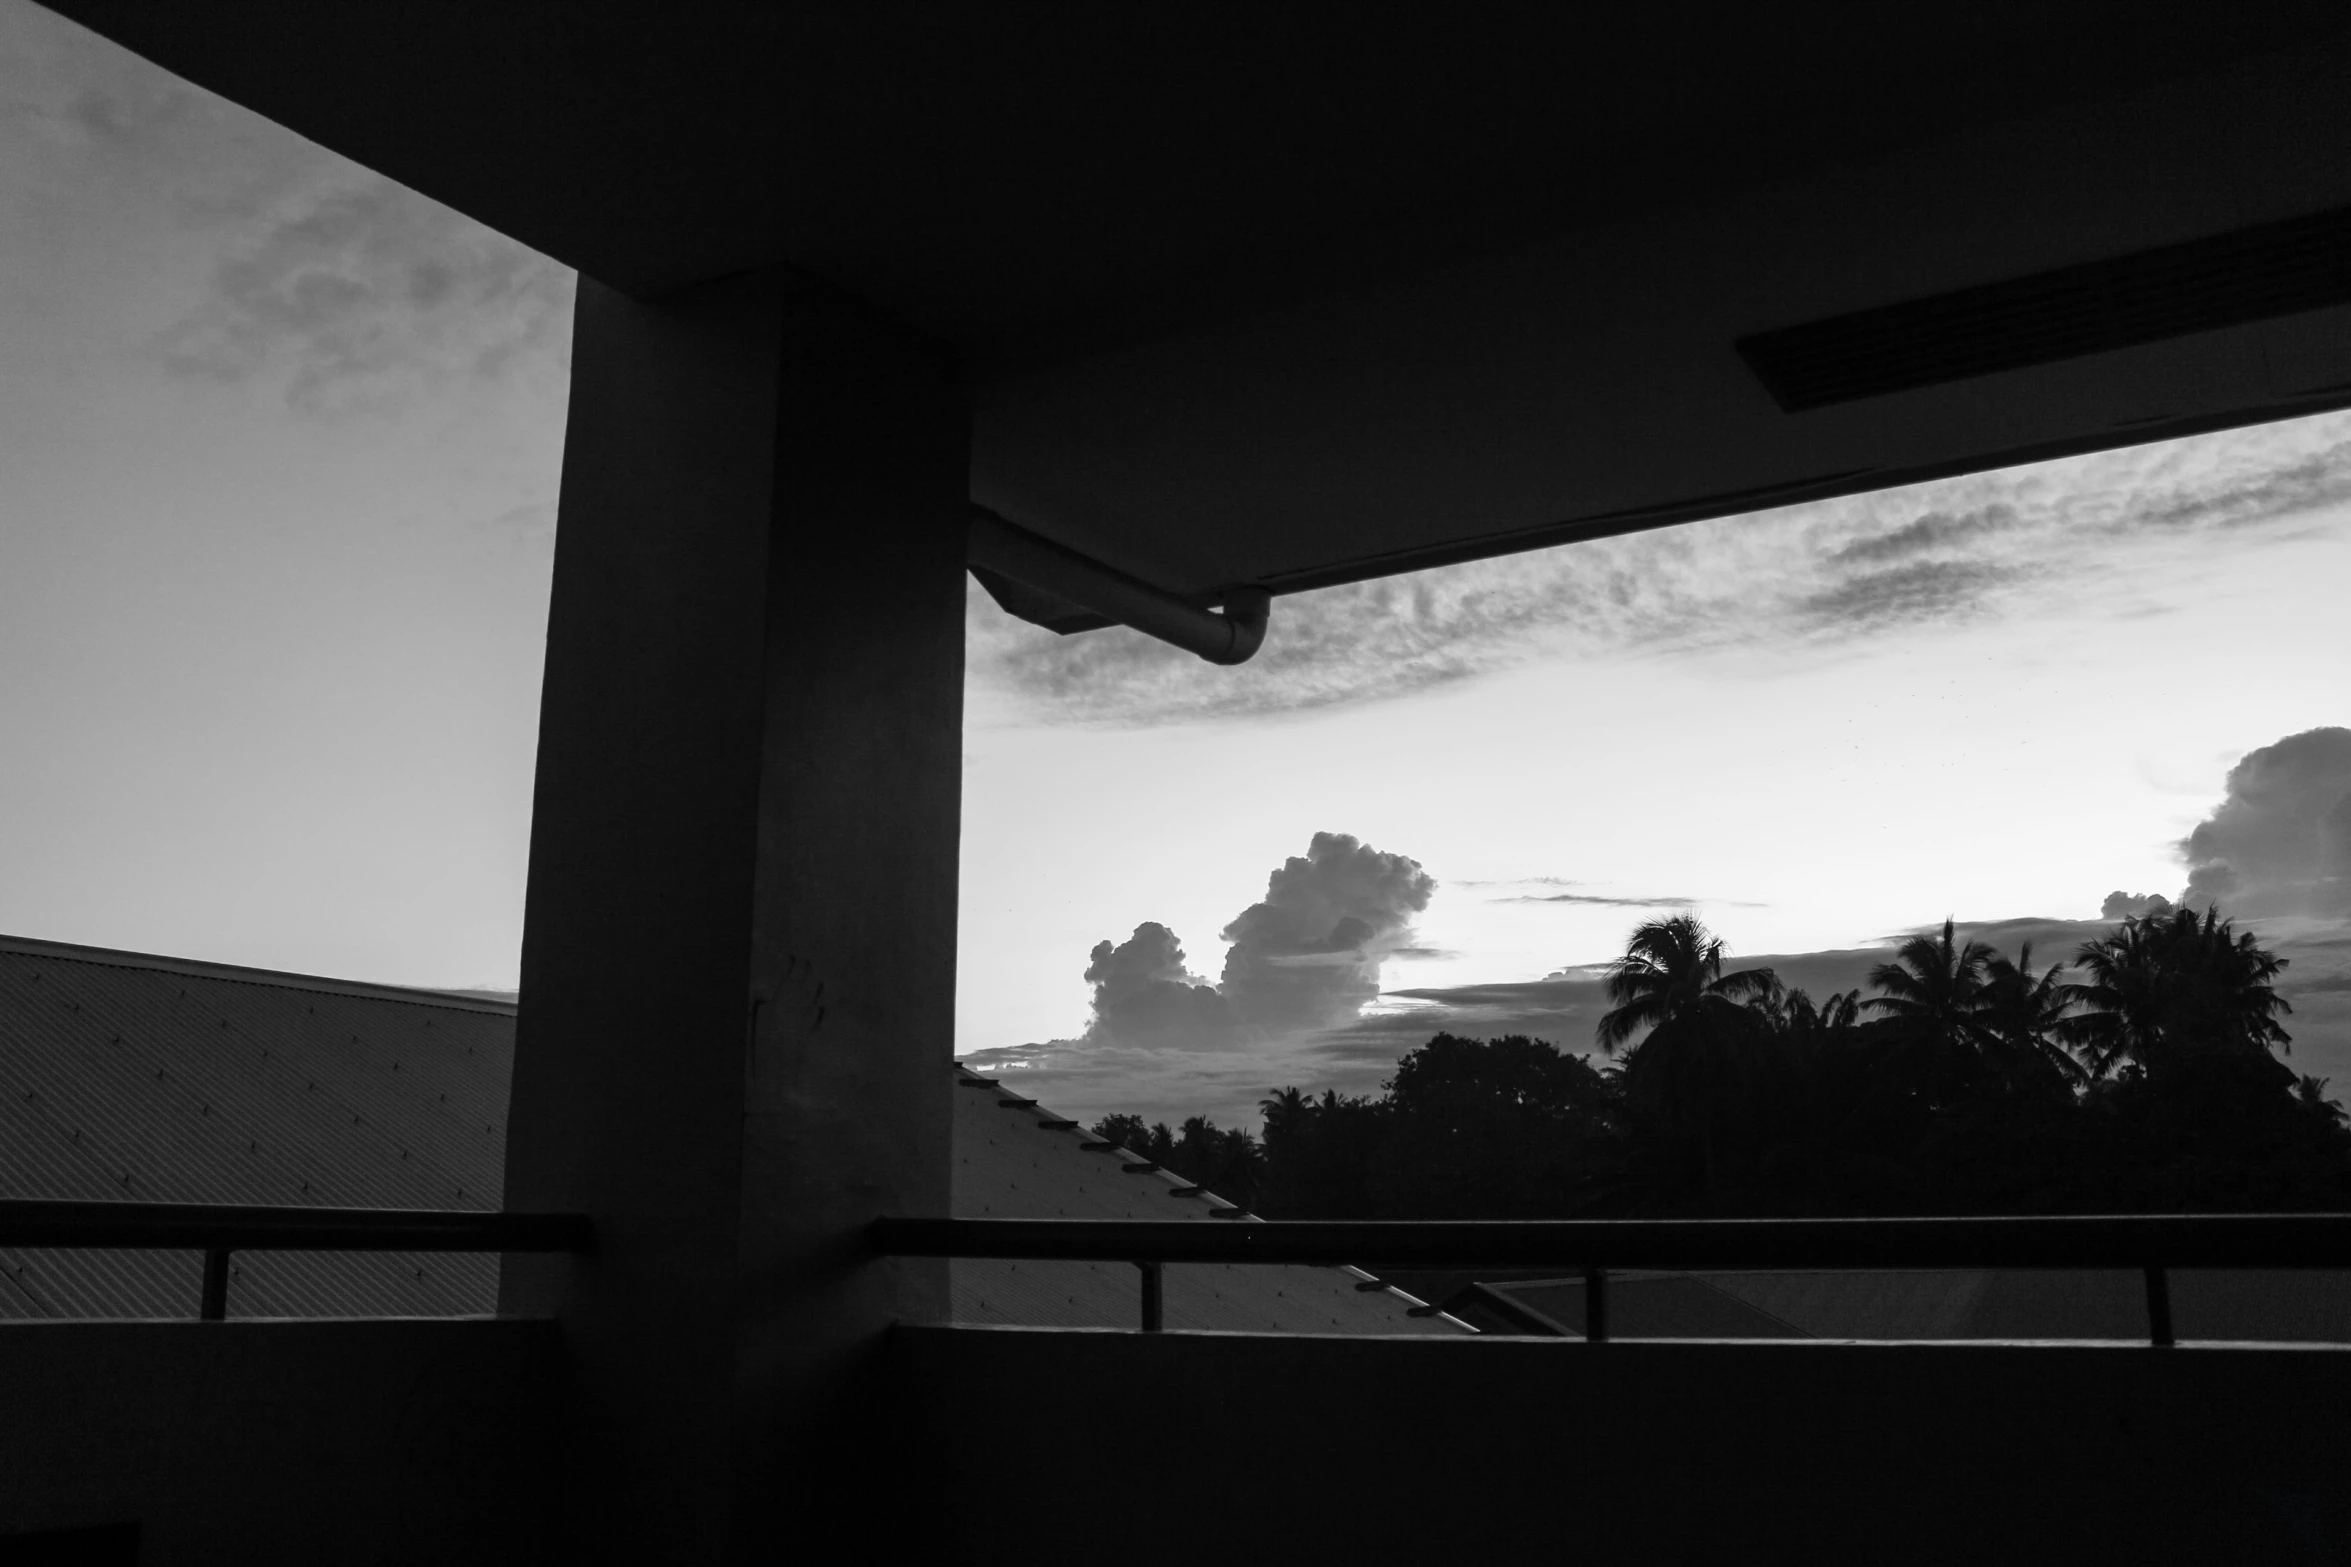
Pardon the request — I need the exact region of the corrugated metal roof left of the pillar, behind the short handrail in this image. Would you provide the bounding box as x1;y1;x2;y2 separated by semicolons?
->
0;937;515;1318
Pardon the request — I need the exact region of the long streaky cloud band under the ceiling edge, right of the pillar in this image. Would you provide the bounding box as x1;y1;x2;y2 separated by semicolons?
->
969;413;2351;724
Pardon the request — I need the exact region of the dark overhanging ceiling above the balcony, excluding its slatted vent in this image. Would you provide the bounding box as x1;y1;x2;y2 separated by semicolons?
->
41;0;2351;599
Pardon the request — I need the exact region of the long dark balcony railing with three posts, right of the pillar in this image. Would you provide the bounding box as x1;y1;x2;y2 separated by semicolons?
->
870;1212;2351;1346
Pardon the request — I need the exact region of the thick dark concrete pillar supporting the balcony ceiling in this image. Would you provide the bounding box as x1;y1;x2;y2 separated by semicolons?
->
501;275;969;1562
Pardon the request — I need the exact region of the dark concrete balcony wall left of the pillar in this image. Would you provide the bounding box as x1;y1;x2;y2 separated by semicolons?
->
0;1318;557;1567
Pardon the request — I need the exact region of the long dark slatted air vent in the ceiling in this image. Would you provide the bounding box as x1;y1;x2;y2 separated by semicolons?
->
1737;207;2351;413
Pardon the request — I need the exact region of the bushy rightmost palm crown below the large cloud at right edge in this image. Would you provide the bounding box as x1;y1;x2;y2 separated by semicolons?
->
2067;904;2295;1074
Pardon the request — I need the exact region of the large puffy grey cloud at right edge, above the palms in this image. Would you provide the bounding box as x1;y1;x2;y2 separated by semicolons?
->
2179;728;2351;919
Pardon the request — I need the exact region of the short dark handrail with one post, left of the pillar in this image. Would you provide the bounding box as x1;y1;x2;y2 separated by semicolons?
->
0;1201;595;1323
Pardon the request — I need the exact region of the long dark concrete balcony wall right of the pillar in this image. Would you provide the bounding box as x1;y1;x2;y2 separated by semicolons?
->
896;1327;2351;1567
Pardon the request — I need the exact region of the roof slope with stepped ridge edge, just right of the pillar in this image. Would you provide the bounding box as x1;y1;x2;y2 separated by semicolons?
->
950;1069;1467;1334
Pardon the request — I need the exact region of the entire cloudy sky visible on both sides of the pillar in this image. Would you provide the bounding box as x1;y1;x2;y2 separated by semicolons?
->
0;0;2351;1123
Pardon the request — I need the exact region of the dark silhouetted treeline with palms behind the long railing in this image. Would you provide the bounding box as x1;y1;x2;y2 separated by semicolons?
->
1096;909;2351;1219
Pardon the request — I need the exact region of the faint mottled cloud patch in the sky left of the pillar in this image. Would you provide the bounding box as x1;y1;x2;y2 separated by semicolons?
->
155;176;576;413
